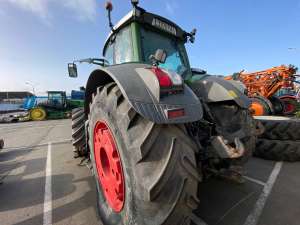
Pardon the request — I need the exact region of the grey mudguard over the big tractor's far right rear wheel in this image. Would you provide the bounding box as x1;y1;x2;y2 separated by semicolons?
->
189;74;251;108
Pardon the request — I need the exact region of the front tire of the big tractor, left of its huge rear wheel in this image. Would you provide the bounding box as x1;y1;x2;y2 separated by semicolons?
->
72;108;87;158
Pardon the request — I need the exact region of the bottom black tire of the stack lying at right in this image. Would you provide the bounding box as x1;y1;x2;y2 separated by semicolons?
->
254;139;300;162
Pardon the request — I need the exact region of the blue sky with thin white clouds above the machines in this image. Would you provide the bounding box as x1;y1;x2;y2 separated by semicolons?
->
0;0;300;93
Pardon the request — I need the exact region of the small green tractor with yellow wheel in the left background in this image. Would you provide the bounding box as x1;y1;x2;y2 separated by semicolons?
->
29;91;83;121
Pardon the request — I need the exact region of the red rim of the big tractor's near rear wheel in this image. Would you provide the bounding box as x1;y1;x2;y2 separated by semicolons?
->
94;121;125;212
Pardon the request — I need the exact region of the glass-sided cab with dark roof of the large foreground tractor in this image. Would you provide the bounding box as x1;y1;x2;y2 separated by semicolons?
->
103;0;196;77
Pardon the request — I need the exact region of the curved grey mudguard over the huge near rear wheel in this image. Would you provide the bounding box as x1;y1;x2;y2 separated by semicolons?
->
85;63;203;124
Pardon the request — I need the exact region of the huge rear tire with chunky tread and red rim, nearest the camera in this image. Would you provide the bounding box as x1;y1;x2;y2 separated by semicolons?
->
89;83;199;225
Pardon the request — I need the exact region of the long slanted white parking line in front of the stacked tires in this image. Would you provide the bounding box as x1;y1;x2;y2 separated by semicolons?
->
244;162;282;225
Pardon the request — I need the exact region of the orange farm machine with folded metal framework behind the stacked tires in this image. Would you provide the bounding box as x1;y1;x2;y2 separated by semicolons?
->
225;65;299;116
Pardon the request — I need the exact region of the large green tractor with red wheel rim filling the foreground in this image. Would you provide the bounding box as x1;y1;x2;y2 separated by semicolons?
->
68;0;256;225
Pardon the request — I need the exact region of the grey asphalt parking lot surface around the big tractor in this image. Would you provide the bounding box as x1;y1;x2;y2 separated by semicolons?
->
0;120;300;225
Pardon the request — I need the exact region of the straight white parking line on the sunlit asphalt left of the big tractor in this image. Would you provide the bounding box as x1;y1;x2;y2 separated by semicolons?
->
43;142;52;225
